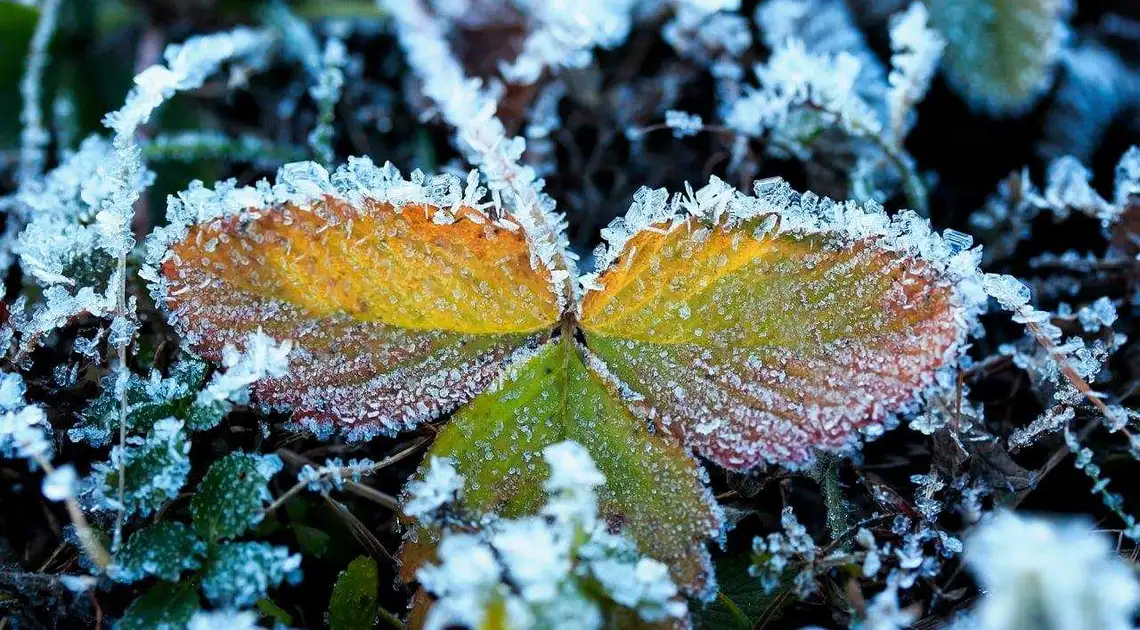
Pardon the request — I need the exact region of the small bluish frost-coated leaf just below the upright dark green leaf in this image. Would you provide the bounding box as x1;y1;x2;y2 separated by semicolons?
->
202;542;301;608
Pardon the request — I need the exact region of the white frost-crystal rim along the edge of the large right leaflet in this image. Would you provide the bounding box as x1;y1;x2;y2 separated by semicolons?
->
576;175;988;473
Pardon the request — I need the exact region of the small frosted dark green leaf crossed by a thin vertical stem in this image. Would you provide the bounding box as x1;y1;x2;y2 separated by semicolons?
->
90;418;190;517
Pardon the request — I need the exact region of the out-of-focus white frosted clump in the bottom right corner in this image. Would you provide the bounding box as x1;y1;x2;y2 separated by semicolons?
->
966;512;1140;630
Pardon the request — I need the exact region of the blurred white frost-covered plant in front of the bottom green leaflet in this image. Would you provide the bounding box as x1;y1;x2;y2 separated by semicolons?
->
406;442;687;630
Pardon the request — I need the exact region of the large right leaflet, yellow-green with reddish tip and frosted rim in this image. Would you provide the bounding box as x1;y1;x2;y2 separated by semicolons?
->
581;180;977;469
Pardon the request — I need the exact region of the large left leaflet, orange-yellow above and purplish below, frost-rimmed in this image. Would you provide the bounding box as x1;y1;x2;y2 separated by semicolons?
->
150;159;560;437
